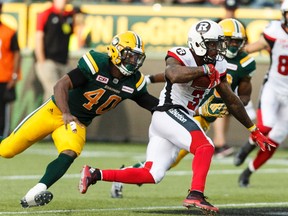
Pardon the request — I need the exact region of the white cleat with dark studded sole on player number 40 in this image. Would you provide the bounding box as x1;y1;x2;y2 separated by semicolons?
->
20;191;53;208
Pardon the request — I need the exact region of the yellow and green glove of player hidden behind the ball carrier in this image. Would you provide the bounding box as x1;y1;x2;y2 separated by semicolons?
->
198;95;229;118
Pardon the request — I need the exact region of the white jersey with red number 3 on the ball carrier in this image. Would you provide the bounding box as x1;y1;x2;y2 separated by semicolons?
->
159;47;227;115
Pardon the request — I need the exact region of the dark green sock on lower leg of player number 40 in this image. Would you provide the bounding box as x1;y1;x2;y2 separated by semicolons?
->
39;153;74;188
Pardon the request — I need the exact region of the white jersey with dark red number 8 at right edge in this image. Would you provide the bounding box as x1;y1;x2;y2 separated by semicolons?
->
264;21;288;95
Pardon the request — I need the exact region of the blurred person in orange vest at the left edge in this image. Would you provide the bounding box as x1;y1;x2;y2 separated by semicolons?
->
0;2;20;136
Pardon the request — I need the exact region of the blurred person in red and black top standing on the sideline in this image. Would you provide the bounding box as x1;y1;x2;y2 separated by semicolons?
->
35;0;74;100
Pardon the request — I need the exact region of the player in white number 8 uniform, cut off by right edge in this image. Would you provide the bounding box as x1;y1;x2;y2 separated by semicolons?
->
234;0;288;187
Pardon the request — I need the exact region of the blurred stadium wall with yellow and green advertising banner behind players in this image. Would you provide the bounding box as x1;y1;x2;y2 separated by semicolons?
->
2;0;281;146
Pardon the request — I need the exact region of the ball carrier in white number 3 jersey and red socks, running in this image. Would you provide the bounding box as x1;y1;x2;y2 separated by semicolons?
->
79;20;273;214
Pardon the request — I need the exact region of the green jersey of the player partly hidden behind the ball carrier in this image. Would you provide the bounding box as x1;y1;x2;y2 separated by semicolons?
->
201;51;256;122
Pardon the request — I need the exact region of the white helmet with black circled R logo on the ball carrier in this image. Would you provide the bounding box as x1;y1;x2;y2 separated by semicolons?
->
188;20;226;63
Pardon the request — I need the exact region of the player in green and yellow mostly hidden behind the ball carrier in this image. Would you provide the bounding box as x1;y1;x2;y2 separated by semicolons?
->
111;18;256;198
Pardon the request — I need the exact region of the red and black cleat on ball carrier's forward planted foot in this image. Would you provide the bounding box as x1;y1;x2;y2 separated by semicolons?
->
183;191;219;215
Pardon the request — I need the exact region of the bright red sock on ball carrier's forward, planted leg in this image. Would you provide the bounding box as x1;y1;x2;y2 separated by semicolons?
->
191;144;214;192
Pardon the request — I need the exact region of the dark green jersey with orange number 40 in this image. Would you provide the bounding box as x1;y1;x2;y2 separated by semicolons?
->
52;50;147;126
